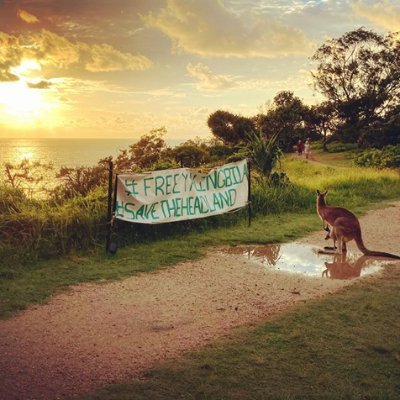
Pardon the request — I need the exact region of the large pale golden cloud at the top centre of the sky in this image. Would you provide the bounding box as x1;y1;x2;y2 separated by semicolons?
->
142;0;311;57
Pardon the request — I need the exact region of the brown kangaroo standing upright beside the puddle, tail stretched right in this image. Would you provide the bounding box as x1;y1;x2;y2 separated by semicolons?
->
317;190;400;259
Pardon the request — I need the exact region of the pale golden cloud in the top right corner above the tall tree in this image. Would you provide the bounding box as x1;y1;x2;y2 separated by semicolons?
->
352;0;400;32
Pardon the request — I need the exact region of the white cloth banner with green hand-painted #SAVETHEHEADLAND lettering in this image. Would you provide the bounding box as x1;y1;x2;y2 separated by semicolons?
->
115;160;249;224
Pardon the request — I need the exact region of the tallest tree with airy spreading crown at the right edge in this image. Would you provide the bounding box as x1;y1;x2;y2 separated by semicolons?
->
312;28;400;145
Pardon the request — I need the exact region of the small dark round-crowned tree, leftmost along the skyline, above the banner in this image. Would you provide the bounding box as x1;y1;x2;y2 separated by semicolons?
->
207;110;255;146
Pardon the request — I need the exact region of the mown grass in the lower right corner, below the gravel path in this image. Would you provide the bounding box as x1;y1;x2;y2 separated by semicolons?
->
81;268;400;400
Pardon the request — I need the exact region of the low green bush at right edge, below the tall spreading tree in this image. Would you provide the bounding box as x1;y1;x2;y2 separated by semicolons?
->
354;145;400;168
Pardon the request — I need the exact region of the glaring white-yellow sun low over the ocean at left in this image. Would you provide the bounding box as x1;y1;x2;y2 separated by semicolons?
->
0;60;61;128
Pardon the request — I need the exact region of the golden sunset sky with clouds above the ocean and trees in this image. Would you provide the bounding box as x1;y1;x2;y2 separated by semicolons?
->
0;0;400;139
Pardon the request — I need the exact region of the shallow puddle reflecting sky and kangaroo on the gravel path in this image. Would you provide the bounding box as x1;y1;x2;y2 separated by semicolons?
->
224;243;393;279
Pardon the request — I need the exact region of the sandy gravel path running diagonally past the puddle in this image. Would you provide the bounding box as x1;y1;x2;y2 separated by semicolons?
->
0;202;400;400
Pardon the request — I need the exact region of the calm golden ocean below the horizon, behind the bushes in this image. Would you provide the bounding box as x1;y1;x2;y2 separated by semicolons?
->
0;138;180;170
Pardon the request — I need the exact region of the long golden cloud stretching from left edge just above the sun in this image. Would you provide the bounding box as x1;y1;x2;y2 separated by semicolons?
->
0;29;153;81
